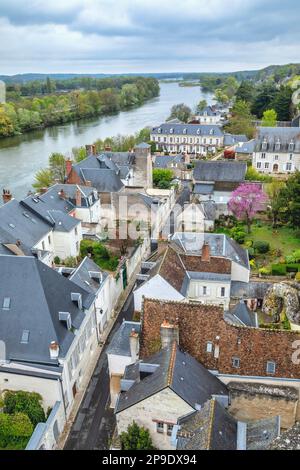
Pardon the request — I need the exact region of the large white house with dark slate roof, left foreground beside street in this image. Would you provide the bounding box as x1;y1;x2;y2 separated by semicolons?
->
0;255;99;446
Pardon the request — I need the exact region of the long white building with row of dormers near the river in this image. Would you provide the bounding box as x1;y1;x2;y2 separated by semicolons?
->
150;123;224;155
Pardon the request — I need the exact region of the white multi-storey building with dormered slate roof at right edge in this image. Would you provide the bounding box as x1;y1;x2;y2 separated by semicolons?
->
252;127;300;174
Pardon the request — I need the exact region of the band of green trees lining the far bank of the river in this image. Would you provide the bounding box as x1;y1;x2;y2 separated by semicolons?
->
0;77;159;137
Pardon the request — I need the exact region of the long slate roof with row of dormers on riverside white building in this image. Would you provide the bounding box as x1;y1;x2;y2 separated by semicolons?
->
151;123;224;137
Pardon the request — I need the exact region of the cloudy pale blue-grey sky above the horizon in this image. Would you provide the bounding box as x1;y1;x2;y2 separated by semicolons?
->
0;0;300;75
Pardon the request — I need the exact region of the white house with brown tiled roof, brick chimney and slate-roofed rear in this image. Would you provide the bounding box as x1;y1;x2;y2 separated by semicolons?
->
133;233;250;312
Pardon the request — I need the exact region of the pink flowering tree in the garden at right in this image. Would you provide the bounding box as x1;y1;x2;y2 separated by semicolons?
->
228;183;267;233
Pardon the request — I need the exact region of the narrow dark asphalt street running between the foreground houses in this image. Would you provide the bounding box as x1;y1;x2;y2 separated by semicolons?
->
65;293;134;450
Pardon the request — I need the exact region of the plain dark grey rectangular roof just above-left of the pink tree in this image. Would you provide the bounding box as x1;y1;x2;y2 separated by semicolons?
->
193;161;247;183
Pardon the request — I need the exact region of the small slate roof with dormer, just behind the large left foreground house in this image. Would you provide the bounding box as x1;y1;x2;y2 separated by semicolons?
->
69;256;108;294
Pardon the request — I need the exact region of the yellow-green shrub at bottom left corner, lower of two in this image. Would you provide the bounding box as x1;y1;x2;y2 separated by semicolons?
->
0;413;34;450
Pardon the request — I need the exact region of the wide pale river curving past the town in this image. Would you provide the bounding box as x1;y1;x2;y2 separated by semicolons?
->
0;82;212;199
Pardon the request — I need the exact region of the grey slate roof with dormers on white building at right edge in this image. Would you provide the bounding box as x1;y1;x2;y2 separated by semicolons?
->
255;127;300;153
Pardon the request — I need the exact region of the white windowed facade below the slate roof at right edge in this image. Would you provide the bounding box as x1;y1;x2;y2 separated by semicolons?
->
252;151;300;174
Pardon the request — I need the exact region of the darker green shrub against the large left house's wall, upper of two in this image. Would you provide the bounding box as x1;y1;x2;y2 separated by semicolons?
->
4;390;46;426
